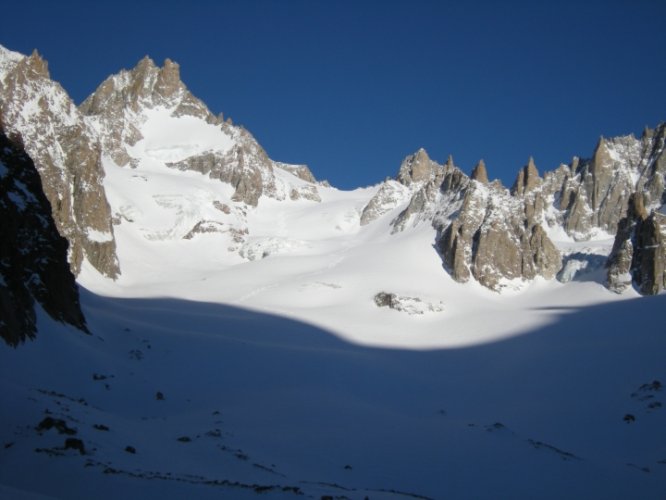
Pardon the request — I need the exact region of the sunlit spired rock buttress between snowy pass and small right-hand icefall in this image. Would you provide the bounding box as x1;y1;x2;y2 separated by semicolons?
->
361;149;561;290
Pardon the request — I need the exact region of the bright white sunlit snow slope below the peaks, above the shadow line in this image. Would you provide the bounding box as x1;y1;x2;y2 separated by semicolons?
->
79;143;634;348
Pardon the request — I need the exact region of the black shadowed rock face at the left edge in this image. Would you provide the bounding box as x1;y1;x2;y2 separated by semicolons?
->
0;127;87;346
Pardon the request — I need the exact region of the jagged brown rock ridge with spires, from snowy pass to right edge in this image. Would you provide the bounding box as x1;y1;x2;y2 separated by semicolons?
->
361;124;666;294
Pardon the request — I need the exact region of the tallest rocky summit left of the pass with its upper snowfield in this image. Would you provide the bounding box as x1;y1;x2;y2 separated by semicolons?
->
80;57;318;206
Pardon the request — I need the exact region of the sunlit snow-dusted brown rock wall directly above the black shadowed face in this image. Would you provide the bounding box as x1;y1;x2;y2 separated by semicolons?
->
0;47;120;278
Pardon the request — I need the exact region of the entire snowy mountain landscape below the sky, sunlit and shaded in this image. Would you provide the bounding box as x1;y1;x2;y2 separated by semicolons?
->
0;47;666;498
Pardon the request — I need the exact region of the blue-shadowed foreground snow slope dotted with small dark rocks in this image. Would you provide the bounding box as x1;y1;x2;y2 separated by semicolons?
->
0;292;666;499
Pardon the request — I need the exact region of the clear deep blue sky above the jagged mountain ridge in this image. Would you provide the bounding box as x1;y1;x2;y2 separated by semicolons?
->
0;0;666;188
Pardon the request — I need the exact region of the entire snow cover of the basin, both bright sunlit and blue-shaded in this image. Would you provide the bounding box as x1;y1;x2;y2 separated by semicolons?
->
0;124;666;499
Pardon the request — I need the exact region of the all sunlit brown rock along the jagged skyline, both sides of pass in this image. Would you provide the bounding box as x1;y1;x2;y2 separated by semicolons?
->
0;43;666;294
